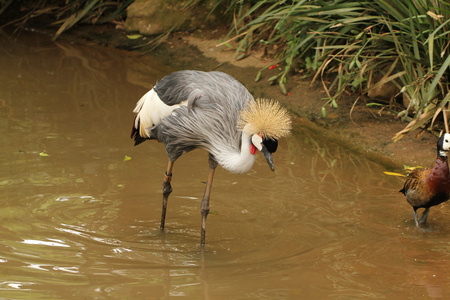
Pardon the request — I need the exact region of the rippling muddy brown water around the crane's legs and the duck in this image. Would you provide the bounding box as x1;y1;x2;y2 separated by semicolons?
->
0;29;450;299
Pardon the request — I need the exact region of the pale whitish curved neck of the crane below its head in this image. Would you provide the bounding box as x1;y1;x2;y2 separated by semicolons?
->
211;127;255;174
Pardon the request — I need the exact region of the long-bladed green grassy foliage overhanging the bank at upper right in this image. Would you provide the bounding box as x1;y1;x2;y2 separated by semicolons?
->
222;0;450;139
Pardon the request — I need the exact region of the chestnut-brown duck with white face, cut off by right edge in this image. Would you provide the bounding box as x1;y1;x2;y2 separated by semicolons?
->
400;133;450;226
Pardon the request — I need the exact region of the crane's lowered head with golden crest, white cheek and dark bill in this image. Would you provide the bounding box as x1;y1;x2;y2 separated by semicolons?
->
238;99;292;171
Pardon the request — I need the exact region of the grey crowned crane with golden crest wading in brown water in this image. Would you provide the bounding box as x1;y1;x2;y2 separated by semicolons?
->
131;70;291;246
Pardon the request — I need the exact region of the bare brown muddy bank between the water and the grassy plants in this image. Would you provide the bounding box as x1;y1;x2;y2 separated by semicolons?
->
63;26;437;171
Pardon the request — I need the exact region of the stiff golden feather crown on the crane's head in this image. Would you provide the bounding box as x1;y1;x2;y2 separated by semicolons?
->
238;99;292;139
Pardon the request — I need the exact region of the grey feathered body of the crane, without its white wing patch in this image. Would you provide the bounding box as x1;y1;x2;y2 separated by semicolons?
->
136;71;254;173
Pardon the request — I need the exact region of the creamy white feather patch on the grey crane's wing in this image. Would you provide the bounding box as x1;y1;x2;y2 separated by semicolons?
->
133;89;187;137
